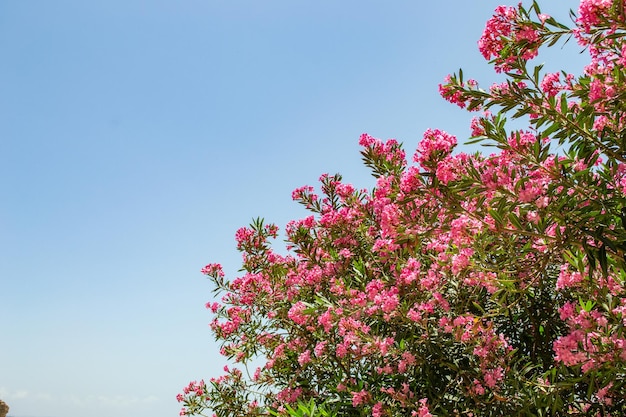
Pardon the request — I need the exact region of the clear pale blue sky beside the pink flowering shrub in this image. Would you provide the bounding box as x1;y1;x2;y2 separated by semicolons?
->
0;0;577;417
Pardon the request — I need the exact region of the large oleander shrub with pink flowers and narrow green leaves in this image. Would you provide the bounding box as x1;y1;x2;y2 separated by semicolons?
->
178;0;626;417
